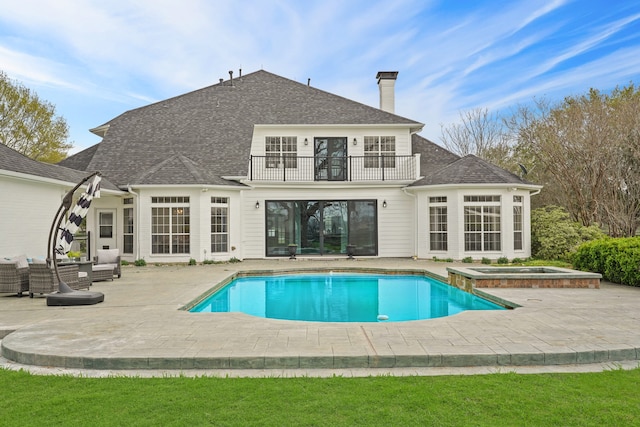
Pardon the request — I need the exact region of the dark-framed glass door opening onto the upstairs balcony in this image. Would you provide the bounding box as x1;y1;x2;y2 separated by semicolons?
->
314;137;347;181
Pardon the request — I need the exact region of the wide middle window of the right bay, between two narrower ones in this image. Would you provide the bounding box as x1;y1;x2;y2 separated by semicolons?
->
464;196;501;251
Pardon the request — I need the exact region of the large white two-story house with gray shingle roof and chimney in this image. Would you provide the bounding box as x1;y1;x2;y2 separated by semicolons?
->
60;70;541;262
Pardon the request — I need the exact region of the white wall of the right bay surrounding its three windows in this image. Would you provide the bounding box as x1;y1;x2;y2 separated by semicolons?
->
415;185;531;260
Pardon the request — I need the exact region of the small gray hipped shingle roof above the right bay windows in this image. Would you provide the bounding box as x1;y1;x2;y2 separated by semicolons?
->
413;154;531;186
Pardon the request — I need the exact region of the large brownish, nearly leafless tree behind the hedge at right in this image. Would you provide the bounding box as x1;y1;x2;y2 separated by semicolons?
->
510;84;640;236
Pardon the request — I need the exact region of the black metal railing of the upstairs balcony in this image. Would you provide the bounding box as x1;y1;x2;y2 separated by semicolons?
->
249;155;419;182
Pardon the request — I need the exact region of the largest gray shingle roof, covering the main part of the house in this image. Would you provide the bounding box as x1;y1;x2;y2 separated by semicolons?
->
71;71;422;186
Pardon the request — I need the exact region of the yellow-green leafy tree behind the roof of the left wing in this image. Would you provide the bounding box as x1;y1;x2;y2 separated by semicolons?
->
0;71;72;163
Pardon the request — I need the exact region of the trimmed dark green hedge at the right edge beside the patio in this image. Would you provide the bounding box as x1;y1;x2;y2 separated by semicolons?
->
572;237;640;286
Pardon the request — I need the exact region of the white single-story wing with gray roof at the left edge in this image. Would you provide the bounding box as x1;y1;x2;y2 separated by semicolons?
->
0;144;124;258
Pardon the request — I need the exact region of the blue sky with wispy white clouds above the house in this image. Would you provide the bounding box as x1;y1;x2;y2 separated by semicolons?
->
0;0;640;152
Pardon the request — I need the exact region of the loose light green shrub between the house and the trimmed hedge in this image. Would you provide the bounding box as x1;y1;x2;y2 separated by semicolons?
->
531;206;606;260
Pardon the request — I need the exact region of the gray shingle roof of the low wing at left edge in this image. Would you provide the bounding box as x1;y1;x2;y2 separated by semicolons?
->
0;144;117;190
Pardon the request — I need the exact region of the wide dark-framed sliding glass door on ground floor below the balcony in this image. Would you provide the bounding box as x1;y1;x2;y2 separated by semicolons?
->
266;200;378;256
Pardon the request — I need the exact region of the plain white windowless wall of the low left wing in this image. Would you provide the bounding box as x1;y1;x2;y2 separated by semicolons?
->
0;176;71;258
